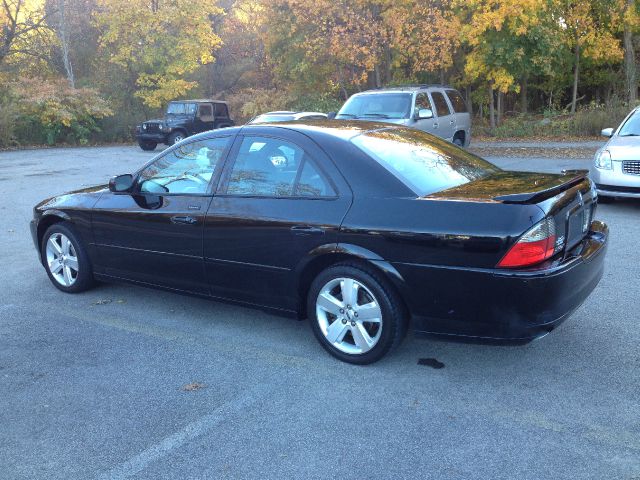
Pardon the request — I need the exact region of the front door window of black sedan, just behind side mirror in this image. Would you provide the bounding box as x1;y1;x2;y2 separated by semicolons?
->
138;137;230;195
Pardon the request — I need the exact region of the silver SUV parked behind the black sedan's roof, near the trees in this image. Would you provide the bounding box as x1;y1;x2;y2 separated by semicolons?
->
331;85;471;147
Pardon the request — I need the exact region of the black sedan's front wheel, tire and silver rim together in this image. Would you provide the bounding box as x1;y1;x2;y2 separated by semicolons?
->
40;222;95;293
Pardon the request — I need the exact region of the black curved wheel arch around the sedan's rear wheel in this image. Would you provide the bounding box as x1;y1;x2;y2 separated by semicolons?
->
296;243;409;318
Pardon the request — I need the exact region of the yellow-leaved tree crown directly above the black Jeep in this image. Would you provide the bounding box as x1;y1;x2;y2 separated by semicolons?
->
94;0;222;108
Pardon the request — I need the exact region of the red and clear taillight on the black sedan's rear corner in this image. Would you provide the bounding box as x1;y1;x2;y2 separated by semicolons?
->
498;217;556;268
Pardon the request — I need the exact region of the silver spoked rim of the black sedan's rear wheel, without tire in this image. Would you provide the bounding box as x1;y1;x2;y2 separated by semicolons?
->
316;278;382;355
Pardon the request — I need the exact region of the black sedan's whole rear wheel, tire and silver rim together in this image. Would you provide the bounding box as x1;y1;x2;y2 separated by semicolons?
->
307;264;407;365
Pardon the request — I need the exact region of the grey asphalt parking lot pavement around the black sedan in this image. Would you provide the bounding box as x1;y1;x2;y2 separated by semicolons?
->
0;147;640;480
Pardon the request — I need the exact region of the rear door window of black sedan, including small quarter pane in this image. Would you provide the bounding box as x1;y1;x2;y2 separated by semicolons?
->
227;137;335;197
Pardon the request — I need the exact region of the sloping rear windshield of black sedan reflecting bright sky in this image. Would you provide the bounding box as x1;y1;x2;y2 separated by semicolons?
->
351;128;500;196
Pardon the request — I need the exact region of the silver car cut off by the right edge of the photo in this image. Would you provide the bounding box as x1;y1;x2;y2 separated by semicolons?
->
590;107;640;198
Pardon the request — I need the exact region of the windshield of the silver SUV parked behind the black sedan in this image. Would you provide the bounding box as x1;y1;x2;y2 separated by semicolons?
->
336;93;413;119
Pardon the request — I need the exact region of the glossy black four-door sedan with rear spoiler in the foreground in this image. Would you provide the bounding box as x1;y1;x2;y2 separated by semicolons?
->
31;121;608;364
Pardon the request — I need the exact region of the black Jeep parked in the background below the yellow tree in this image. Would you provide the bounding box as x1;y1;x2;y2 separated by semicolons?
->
136;100;235;151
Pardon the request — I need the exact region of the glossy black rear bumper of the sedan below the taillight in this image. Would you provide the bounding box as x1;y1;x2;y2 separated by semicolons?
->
394;221;608;342
